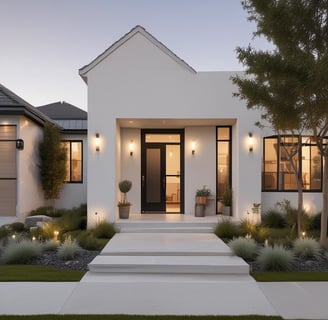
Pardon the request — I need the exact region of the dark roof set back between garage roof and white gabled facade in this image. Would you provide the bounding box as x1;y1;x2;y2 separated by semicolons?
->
38;101;88;133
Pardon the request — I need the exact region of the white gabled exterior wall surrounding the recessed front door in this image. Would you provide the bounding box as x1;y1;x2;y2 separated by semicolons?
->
87;30;261;226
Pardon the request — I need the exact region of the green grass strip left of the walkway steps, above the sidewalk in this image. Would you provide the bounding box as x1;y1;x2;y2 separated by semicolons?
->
0;265;84;282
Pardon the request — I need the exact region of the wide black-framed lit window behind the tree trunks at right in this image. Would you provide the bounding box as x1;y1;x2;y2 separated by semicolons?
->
262;136;323;191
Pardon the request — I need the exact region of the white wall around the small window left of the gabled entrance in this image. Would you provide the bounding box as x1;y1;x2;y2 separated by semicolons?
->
55;134;88;209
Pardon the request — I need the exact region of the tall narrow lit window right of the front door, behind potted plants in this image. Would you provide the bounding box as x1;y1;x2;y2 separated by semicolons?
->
216;126;231;205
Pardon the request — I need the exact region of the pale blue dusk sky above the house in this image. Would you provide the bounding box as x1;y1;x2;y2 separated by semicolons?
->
0;0;268;110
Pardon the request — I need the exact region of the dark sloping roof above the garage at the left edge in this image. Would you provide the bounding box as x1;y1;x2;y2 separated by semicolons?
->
0;84;53;125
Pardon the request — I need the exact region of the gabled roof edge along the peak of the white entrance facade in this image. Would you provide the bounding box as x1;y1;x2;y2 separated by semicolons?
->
79;26;196;83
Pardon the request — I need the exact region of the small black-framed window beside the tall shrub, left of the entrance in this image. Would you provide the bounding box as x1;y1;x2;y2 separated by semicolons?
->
63;140;83;183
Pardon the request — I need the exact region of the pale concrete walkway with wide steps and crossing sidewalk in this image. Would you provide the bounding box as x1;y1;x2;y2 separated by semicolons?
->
0;233;328;319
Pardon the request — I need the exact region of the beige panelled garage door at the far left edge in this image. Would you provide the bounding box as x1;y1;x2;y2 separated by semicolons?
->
0;125;17;217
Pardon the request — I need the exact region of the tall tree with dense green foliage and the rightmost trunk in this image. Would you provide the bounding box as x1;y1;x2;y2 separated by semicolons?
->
232;0;328;243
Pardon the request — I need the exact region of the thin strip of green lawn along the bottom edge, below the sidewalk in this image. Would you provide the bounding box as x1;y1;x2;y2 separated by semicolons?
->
0;315;282;320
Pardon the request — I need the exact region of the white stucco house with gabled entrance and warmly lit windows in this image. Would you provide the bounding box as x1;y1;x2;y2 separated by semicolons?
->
0;26;322;227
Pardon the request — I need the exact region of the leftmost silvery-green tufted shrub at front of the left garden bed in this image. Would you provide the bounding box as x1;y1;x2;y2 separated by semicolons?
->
0;240;42;264
